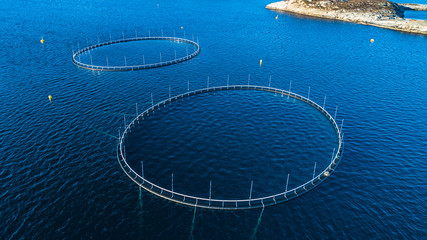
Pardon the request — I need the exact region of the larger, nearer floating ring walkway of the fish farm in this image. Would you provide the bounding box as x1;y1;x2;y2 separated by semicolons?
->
117;85;344;210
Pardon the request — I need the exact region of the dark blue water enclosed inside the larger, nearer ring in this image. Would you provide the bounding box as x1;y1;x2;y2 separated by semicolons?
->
124;90;338;199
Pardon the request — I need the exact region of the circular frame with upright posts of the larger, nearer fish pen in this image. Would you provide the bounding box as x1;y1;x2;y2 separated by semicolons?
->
117;85;344;210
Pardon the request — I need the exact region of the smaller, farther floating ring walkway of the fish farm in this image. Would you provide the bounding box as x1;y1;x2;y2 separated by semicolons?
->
72;37;200;71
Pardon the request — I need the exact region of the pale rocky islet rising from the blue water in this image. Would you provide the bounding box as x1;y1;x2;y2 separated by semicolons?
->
266;0;427;35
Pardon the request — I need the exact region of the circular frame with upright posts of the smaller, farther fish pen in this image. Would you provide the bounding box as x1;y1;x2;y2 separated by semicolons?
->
72;36;200;71
